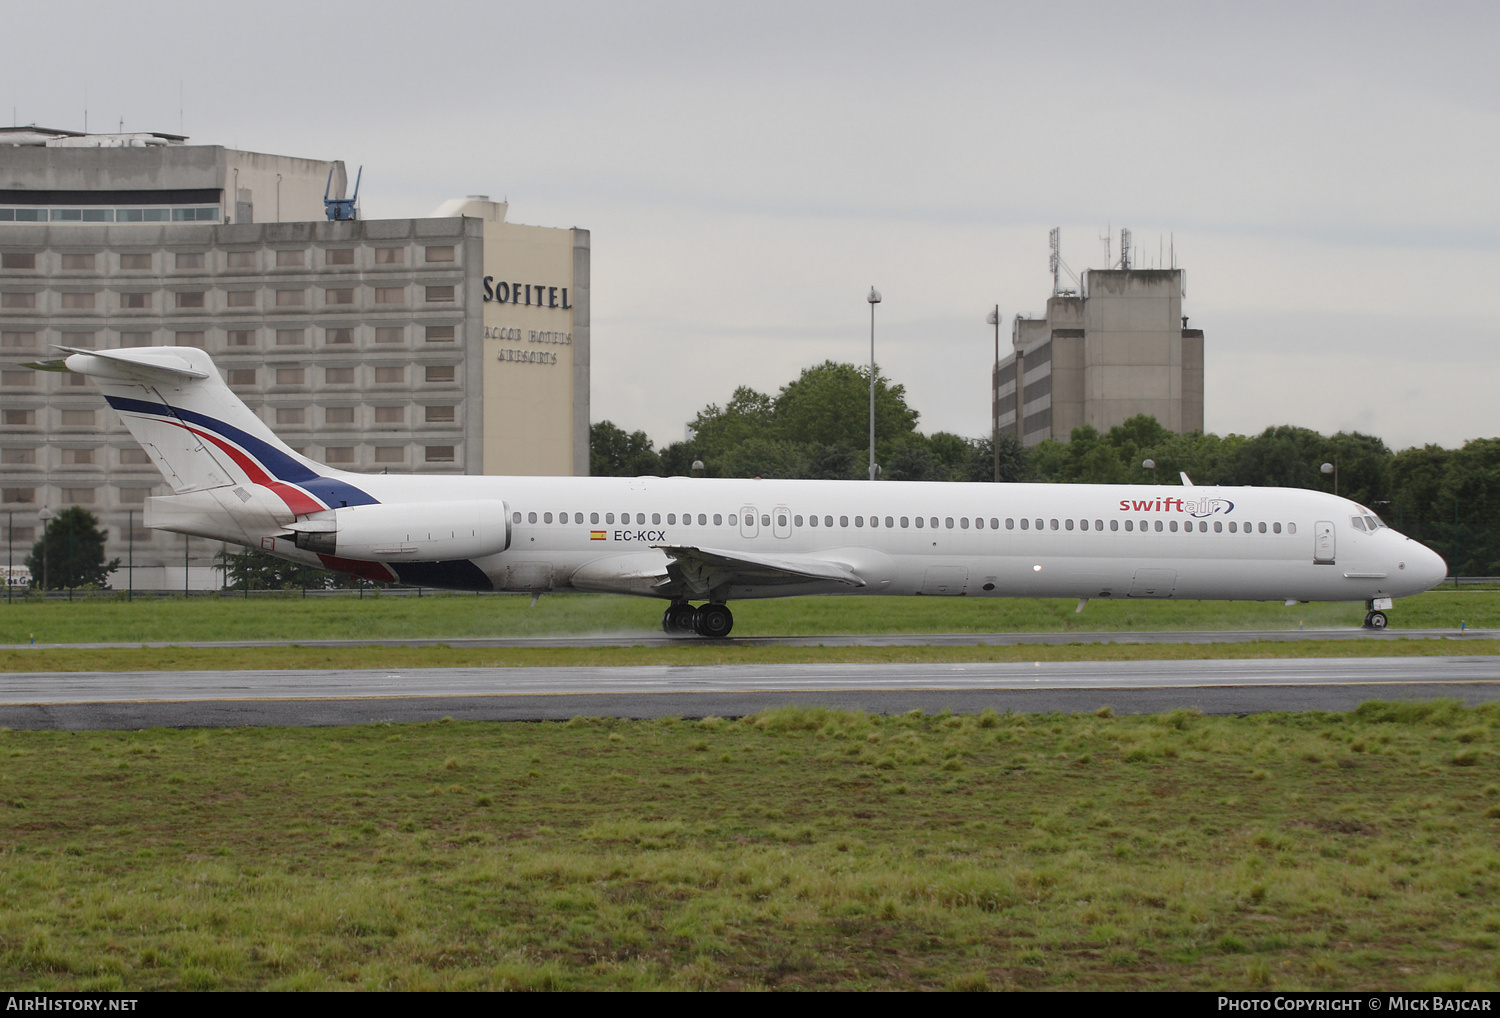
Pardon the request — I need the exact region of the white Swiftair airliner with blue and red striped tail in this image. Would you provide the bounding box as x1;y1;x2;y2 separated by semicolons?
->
63;348;1446;637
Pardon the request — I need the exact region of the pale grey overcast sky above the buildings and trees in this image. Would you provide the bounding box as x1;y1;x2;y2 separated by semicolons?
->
0;0;1500;448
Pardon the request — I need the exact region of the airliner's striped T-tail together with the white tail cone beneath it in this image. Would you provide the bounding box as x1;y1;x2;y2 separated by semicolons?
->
63;346;377;546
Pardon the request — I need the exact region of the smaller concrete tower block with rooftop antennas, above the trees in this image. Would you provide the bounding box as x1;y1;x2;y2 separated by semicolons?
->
992;268;1203;445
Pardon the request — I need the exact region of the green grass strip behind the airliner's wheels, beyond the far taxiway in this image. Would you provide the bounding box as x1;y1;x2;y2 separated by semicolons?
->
0;591;1500;645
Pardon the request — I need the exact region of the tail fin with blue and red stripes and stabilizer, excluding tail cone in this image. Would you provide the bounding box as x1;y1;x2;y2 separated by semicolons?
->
63;346;375;516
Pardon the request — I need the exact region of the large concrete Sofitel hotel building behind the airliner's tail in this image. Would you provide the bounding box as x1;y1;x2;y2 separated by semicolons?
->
0;129;590;589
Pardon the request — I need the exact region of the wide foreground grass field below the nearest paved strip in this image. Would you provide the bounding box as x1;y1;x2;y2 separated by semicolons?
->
0;702;1500;991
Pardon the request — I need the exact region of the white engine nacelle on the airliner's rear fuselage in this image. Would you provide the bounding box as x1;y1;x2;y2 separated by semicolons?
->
287;499;510;562
